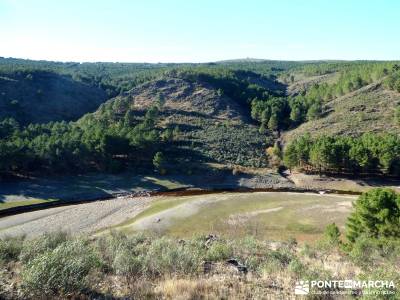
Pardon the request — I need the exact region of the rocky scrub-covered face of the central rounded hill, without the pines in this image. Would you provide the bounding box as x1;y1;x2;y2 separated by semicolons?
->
78;77;266;167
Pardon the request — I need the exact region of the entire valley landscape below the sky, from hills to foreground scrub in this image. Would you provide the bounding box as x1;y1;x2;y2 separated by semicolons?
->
0;58;400;299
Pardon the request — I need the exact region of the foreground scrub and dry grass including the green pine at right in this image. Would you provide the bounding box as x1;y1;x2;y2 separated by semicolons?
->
0;189;400;299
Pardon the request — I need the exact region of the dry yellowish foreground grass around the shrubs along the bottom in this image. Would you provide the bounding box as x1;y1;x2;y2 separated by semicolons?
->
0;234;400;299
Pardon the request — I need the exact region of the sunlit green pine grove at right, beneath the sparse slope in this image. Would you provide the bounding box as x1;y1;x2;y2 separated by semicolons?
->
284;133;400;176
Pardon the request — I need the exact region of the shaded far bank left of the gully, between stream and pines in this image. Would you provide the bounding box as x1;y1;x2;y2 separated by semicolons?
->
0;170;294;211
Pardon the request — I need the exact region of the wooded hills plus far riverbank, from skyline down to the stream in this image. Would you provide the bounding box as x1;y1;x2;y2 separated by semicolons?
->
0;59;400;234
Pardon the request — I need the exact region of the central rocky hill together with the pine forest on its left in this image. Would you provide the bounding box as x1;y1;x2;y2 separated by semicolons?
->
0;68;284;174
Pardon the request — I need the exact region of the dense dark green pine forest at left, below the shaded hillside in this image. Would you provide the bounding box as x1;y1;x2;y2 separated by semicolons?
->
0;106;169;174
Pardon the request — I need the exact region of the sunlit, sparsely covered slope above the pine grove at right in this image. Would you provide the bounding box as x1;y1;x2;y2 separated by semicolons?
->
283;82;400;141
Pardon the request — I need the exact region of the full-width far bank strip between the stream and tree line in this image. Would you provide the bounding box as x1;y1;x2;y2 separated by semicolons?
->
0;169;400;217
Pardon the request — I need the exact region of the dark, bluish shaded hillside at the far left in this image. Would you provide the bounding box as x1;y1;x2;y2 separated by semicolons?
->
0;71;107;124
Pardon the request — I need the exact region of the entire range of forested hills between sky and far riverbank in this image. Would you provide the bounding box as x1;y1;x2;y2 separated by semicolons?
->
0;58;400;175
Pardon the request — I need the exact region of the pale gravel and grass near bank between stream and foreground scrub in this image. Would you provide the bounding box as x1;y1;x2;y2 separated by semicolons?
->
0;191;356;240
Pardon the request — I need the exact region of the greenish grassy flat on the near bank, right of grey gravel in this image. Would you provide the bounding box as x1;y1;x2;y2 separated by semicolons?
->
116;193;351;241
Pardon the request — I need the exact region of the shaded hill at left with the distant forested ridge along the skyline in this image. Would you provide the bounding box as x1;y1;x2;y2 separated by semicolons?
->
0;57;291;125
